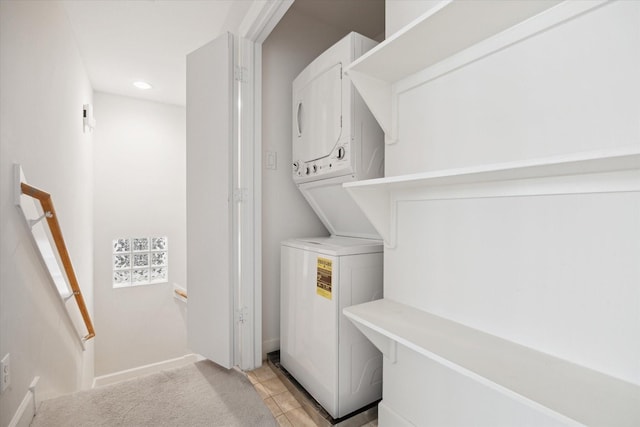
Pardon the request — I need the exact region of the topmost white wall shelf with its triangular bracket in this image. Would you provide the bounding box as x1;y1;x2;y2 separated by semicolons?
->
347;0;601;143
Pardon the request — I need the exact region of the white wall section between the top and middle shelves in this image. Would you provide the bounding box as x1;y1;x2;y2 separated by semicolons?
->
385;1;640;175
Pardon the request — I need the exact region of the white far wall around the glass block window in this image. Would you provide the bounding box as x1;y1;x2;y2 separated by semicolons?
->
93;92;188;376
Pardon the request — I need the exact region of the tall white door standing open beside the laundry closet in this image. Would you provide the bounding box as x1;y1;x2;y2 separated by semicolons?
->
187;33;234;368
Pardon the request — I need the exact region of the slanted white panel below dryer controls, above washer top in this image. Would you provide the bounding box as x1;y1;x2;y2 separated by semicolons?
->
298;176;380;239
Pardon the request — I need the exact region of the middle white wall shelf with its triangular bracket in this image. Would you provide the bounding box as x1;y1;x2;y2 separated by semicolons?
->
343;149;640;247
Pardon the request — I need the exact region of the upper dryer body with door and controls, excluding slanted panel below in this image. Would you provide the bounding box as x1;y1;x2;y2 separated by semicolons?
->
291;33;384;184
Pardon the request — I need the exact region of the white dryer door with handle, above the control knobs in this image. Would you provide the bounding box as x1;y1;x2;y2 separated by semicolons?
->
293;63;342;162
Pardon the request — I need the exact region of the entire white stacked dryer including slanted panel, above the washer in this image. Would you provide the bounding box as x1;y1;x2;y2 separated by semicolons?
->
292;33;384;239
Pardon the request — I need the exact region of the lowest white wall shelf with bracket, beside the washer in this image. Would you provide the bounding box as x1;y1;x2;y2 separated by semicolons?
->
344;299;640;426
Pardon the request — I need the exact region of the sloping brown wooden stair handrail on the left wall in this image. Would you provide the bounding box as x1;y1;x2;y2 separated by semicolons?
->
20;182;96;341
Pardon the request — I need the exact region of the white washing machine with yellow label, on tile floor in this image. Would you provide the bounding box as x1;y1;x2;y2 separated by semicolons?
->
280;236;383;418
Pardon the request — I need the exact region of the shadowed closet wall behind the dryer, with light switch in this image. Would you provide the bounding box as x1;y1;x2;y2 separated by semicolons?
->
262;3;347;352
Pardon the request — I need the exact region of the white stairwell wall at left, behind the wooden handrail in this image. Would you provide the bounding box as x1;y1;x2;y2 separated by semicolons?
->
0;1;95;426
